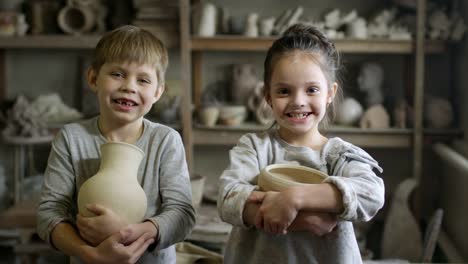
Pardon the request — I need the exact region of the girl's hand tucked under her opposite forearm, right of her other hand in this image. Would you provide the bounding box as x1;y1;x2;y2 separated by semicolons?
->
288;211;338;236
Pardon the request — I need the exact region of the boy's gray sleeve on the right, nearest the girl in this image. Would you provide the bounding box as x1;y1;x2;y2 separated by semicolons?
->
148;131;195;251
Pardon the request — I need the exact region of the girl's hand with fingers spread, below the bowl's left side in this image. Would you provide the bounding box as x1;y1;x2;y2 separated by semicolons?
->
255;190;298;234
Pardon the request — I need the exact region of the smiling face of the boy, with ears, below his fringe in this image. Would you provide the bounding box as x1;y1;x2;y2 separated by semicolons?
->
87;62;164;127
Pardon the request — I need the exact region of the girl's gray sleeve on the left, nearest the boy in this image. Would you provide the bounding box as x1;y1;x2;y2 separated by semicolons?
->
218;136;260;228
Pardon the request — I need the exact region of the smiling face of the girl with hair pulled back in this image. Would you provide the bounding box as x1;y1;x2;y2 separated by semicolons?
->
266;52;337;141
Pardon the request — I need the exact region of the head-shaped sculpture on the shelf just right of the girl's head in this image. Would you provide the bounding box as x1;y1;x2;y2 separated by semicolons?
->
357;63;384;107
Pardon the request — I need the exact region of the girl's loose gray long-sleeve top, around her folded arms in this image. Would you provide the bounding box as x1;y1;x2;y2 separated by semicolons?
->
218;130;385;264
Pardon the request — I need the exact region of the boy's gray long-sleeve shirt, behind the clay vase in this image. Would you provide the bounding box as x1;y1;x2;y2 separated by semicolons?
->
37;118;195;263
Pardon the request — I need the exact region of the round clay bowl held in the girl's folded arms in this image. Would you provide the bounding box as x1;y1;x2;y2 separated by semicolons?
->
258;164;328;192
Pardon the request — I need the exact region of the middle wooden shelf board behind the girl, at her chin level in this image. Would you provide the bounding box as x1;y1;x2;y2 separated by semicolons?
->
193;123;463;148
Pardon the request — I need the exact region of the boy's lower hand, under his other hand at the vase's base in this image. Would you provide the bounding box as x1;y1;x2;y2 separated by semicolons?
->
85;231;154;264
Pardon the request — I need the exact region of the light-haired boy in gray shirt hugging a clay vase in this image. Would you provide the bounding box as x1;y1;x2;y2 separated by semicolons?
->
37;26;195;263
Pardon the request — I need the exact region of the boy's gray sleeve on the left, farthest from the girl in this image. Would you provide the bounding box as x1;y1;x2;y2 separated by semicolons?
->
37;130;75;244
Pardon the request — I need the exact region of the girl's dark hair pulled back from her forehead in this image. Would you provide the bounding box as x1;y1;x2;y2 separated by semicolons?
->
263;23;340;127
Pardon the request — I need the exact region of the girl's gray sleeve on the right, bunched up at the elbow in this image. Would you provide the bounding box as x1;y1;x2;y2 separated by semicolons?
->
325;143;385;221
